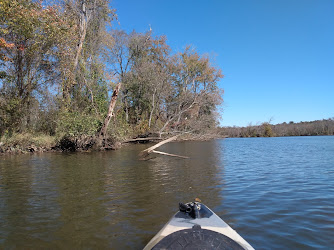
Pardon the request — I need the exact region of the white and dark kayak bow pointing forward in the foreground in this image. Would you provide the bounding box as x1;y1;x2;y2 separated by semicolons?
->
144;201;254;250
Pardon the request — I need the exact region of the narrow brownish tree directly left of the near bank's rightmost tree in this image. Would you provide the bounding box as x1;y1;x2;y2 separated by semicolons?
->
127;34;170;128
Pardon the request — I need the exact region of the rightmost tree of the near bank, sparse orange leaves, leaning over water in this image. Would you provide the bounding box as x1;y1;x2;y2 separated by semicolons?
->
160;47;223;133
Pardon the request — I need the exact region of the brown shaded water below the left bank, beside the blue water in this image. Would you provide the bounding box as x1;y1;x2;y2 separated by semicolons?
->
0;142;223;249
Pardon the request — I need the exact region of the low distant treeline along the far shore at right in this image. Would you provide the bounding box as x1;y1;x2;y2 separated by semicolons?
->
219;118;334;137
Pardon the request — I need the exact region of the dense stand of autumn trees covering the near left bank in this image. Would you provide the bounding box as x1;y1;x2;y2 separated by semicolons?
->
0;0;223;150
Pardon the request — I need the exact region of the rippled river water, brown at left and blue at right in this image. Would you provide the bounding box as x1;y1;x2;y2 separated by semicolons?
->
0;136;334;249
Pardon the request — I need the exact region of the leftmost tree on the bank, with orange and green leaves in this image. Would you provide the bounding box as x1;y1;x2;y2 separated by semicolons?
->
0;0;71;135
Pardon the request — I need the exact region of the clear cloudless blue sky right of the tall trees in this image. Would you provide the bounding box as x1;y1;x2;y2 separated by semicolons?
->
112;0;334;126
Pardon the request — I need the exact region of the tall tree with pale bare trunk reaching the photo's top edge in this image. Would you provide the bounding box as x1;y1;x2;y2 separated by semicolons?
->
63;0;116;104
